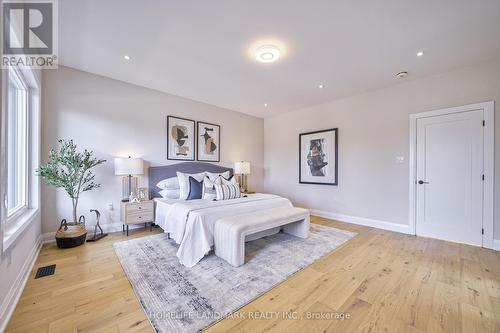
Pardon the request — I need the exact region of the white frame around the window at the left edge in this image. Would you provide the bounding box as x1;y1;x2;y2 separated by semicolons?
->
5;68;31;222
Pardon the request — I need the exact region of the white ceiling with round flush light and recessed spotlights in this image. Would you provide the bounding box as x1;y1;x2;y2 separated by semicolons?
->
59;0;500;117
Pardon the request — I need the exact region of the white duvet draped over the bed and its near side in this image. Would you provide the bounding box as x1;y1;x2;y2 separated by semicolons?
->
159;194;292;267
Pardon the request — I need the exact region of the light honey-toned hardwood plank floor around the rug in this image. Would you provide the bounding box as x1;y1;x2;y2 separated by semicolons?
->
7;217;500;333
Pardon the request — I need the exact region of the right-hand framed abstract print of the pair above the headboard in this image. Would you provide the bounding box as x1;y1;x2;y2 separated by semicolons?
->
196;121;220;162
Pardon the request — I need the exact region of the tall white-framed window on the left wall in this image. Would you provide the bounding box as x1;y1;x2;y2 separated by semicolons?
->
7;69;29;220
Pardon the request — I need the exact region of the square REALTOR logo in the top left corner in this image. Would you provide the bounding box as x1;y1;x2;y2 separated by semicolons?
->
2;0;57;68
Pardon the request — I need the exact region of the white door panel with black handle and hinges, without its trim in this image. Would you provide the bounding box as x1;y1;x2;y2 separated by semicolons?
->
416;110;484;246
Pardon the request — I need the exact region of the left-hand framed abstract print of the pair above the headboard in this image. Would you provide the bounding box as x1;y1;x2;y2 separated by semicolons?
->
167;116;195;161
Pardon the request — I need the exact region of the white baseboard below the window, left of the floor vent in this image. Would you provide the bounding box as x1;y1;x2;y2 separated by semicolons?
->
0;235;42;332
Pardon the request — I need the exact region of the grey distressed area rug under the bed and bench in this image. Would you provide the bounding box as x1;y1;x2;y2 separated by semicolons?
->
113;224;356;333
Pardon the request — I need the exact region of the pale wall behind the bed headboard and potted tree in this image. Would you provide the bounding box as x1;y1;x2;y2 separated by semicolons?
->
42;67;264;233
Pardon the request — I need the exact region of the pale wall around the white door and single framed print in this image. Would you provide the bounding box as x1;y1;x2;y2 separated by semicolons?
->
264;60;500;239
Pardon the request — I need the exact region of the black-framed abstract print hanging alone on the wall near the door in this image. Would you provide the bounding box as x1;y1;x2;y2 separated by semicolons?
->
299;128;338;185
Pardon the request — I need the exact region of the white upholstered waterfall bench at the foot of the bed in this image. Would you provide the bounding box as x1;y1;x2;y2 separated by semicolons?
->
214;207;309;267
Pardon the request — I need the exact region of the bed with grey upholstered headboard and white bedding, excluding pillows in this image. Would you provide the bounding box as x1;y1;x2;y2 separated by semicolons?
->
149;162;292;267
